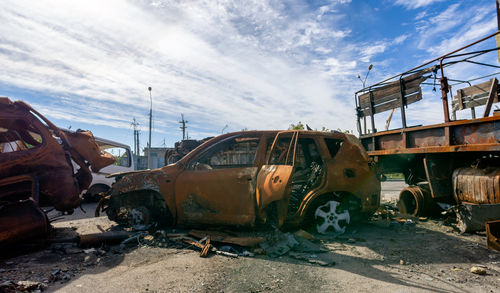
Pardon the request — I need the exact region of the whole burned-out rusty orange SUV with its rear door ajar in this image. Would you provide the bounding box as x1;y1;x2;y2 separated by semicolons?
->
103;130;380;233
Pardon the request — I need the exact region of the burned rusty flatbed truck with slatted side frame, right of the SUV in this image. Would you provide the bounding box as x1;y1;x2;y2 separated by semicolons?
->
355;30;500;232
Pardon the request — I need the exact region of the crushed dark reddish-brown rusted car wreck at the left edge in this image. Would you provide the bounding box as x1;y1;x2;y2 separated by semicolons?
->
0;98;114;243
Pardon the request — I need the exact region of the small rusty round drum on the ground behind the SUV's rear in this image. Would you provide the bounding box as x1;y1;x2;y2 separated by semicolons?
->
398;184;435;216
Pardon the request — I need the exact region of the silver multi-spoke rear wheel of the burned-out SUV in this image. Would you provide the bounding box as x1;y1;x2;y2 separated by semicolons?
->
313;200;351;234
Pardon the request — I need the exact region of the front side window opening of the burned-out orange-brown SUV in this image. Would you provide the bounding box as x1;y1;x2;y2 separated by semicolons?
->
190;137;260;170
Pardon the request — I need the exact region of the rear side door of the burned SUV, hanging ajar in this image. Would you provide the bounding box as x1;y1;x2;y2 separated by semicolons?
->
256;131;299;224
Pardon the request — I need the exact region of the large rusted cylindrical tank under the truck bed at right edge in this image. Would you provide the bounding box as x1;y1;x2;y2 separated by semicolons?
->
453;168;500;204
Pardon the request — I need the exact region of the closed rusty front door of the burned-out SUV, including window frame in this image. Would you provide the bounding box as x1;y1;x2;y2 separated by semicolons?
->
175;134;261;225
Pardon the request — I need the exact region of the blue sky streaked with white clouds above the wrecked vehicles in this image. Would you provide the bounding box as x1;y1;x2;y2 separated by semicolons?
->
0;0;497;147
